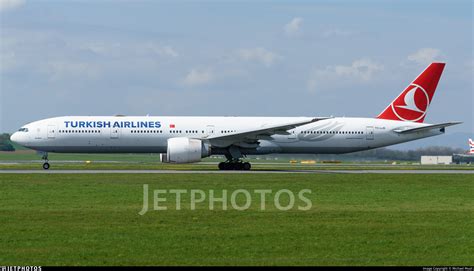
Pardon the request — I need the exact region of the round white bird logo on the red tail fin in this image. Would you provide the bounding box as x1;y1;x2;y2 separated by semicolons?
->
392;84;430;121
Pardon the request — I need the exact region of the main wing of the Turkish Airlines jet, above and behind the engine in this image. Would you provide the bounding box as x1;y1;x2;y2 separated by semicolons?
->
207;118;328;146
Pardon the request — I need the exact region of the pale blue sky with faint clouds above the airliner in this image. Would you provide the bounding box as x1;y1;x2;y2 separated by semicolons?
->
0;0;474;149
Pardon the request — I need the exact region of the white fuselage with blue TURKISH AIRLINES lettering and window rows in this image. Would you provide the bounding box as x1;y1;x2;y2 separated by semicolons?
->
12;116;444;154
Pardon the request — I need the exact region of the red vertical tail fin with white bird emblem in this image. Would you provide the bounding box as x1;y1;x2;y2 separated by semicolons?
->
377;63;445;122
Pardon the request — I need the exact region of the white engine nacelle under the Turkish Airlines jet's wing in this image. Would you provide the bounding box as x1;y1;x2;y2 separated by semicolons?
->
160;137;211;164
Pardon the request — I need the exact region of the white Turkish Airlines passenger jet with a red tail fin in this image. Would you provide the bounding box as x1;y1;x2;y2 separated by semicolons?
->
11;62;461;170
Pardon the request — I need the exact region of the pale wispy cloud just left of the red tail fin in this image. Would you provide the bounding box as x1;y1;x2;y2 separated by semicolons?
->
308;59;384;91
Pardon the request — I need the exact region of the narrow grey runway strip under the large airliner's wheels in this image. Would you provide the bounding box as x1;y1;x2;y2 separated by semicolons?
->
0;169;474;174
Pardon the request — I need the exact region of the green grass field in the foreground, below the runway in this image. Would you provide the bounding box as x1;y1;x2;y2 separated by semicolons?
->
0;174;474;266
